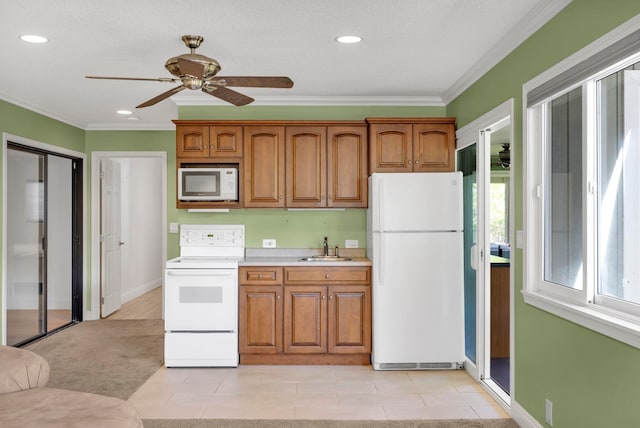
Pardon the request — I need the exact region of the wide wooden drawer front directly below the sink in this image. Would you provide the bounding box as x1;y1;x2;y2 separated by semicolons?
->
284;266;371;285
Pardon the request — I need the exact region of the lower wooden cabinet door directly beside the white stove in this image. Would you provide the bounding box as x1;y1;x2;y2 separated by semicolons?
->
238;285;282;354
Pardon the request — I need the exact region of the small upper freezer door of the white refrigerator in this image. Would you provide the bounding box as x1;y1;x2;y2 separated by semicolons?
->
369;172;462;232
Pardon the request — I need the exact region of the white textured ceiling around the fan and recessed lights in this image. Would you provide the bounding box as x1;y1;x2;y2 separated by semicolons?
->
0;0;569;129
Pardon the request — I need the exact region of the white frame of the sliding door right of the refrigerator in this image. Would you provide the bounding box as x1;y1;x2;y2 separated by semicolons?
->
456;98;517;406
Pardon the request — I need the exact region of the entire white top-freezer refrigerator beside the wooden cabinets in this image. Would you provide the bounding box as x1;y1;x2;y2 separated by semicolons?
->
367;172;464;370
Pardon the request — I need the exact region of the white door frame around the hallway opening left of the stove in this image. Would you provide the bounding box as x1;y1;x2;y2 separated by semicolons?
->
85;151;167;320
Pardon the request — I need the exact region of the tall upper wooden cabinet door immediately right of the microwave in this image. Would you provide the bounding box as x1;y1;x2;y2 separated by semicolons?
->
244;126;285;208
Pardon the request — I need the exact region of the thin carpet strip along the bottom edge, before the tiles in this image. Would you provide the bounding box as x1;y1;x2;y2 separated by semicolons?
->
144;419;518;428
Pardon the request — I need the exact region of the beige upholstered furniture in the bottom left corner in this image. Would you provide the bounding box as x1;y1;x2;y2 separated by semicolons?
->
0;346;142;428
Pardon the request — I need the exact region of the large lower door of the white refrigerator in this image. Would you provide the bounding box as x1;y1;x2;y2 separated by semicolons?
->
372;232;464;367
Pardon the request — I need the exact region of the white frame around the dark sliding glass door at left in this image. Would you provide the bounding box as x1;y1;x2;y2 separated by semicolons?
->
0;132;89;345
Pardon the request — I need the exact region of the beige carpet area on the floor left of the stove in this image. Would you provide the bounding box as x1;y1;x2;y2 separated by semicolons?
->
25;319;164;400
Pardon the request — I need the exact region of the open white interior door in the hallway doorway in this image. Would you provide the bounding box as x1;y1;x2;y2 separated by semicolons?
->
100;159;124;318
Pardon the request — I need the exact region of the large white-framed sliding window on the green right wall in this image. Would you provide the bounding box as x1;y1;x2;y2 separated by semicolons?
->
523;18;640;348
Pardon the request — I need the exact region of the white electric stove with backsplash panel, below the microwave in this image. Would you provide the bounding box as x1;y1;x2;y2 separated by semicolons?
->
164;224;244;367
